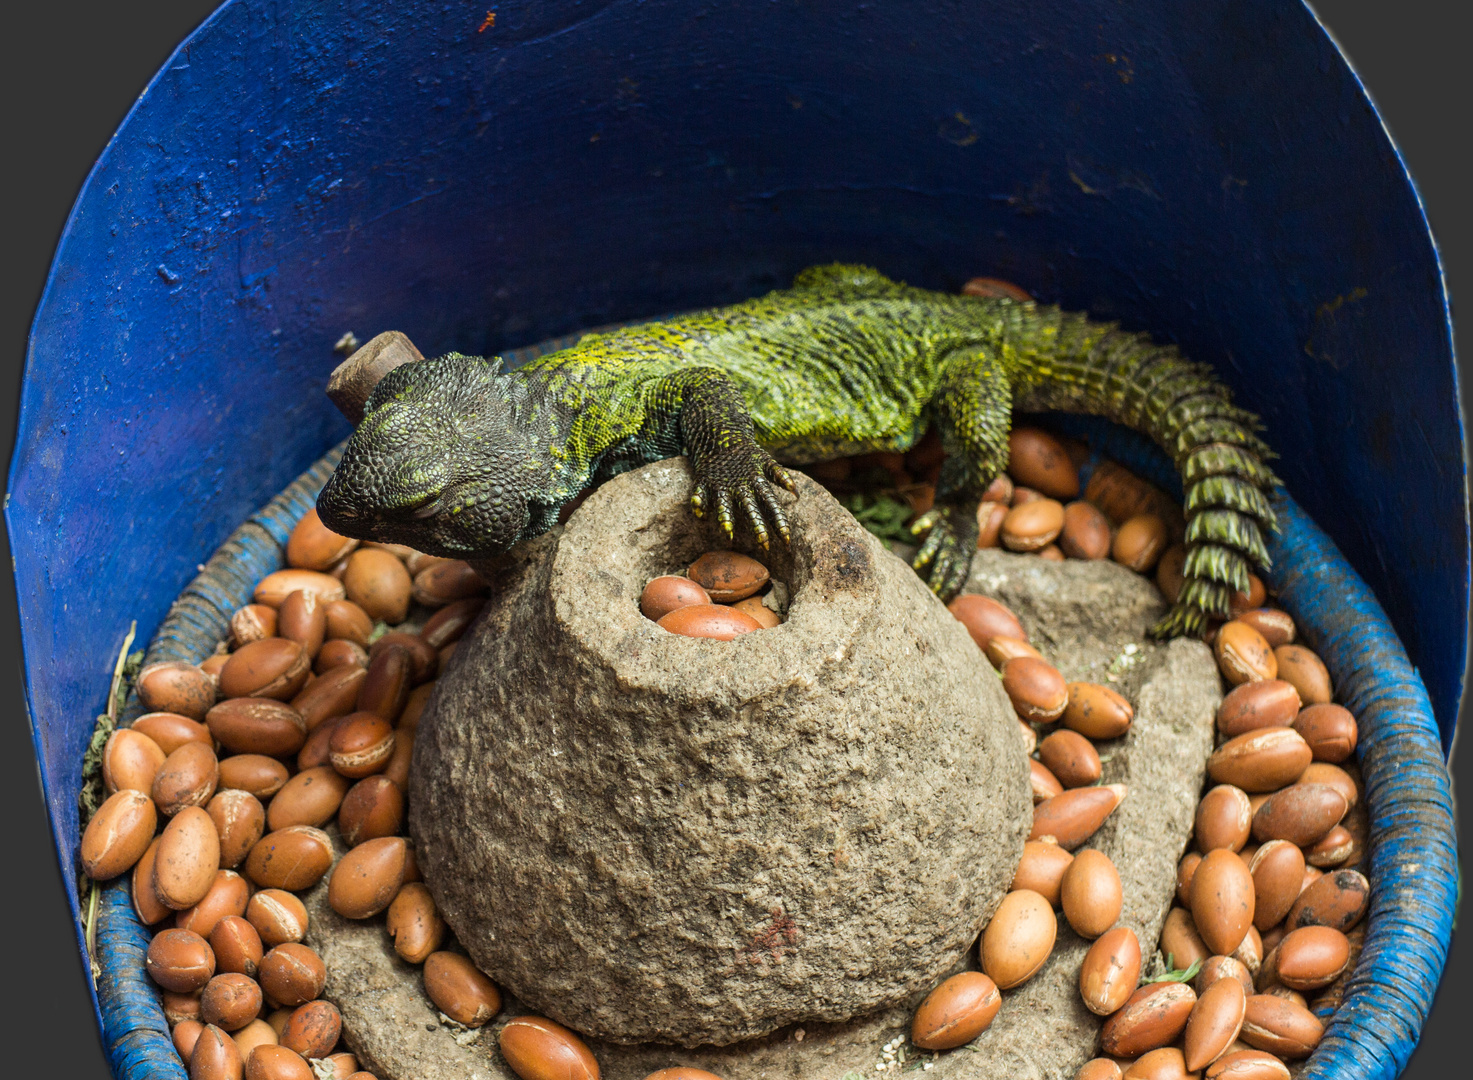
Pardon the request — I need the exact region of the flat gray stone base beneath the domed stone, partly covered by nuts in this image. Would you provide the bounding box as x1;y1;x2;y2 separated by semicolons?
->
308;527;1220;1080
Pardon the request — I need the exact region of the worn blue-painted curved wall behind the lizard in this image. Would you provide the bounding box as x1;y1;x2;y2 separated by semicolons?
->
6;0;1469;1072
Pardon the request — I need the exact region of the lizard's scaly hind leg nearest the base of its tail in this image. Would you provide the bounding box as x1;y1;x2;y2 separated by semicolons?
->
912;349;1012;601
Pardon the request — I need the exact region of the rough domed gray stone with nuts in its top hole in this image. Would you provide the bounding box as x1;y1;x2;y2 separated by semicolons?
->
409;460;1031;1046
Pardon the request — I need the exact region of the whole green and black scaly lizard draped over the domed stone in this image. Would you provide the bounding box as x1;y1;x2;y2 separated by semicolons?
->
318;264;1277;637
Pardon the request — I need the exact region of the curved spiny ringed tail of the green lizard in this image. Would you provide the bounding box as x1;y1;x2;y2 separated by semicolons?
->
982;301;1279;637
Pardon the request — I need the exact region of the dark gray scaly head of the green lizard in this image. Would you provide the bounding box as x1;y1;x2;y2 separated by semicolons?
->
317;354;529;558
